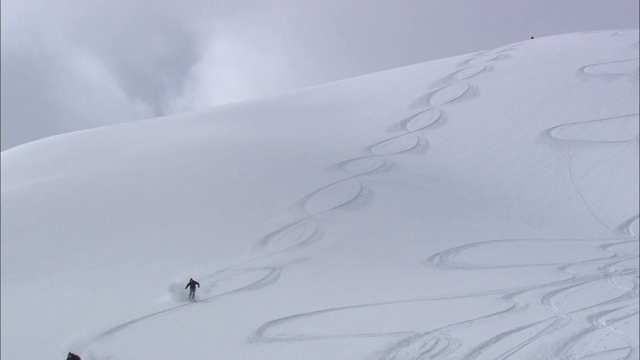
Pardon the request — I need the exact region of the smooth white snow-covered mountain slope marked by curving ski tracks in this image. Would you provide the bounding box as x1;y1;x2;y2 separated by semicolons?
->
1;29;640;360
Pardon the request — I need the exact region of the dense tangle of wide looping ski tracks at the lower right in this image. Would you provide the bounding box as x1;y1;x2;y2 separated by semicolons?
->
245;233;638;359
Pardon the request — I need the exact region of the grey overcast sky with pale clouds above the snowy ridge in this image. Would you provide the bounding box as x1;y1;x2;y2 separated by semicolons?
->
0;0;639;150
